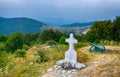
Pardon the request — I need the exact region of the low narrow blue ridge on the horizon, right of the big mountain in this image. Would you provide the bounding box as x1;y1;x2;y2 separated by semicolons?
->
60;22;94;27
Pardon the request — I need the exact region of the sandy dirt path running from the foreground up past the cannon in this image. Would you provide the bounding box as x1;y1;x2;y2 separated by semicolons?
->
41;46;120;77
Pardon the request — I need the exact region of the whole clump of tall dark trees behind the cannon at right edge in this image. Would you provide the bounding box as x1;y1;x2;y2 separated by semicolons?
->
84;16;120;42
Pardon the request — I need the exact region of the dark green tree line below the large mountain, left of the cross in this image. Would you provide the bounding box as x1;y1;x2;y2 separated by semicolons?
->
0;30;81;53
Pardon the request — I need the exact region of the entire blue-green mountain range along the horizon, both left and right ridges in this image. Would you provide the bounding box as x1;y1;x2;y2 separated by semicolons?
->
0;17;94;35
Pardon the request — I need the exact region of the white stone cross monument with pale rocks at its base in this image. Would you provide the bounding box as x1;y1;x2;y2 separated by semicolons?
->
56;33;85;69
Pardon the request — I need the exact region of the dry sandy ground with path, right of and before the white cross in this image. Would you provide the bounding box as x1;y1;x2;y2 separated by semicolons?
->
39;46;120;77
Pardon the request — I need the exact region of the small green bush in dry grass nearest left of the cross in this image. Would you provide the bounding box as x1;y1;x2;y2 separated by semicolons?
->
36;49;48;63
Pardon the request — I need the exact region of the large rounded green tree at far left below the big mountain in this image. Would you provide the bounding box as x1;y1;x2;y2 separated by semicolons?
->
5;32;24;52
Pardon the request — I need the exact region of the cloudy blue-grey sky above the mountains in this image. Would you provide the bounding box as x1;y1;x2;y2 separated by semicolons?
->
0;0;120;24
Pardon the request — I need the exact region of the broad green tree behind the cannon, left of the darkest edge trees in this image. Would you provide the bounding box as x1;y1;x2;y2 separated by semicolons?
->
85;20;112;42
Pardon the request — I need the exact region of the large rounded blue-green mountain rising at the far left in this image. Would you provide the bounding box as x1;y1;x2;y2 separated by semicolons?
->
0;17;46;35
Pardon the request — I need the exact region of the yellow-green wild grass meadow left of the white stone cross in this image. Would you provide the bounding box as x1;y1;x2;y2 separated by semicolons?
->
0;45;71;77
